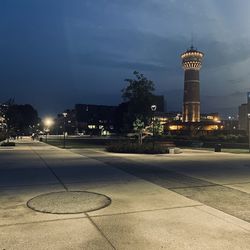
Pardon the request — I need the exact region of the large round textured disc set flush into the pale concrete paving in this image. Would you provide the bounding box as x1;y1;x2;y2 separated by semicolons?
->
27;191;111;214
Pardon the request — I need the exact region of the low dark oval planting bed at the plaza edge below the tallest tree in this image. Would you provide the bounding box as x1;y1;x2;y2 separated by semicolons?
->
106;142;168;154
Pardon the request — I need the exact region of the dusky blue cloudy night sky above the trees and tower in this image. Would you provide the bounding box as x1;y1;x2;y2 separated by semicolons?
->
0;0;250;116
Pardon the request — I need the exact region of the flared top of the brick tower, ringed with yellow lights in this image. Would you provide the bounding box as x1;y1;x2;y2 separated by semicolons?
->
181;46;204;70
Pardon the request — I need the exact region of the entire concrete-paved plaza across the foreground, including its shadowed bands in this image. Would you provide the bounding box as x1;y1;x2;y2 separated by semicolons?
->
0;138;250;250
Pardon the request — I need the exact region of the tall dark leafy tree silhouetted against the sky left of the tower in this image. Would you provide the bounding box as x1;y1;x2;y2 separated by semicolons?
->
122;71;155;128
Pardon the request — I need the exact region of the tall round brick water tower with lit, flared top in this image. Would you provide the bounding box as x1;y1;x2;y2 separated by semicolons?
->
181;46;204;122
